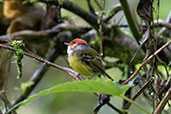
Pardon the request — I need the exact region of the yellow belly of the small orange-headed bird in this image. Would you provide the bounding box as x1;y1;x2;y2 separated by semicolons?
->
68;55;98;76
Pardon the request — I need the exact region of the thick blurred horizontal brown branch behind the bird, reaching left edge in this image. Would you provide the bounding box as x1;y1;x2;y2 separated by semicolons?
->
0;24;90;40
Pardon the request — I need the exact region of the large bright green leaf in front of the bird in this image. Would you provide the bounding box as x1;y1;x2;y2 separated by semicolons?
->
8;79;131;112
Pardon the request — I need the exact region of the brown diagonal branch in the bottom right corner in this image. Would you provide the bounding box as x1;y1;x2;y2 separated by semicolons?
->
154;88;171;114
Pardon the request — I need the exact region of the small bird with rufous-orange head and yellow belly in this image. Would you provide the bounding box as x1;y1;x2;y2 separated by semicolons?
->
65;38;113;80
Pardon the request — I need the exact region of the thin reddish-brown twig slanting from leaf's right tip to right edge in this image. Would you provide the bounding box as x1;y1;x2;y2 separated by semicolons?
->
122;40;171;84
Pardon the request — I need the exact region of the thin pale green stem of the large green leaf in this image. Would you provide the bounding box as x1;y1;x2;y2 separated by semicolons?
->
120;95;151;114
